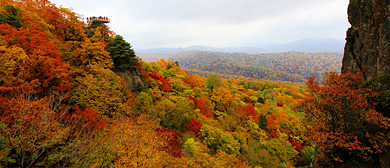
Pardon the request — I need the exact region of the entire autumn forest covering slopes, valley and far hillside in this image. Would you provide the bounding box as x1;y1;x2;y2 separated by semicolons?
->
0;0;390;167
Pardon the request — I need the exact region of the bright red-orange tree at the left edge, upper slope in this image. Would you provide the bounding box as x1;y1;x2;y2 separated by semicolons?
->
0;21;70;96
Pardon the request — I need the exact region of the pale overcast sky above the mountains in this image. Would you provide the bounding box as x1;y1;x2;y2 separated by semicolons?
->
51;0;350;49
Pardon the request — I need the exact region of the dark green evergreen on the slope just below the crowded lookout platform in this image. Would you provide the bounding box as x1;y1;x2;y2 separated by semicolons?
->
107;35;139;70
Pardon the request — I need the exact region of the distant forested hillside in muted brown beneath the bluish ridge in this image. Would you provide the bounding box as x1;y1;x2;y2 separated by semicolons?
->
139;51;343;84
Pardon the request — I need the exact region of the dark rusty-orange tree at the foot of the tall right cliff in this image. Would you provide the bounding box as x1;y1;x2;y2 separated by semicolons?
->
304;73;390;161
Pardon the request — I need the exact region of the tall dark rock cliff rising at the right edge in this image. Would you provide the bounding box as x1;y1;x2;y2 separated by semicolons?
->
341;0;390;80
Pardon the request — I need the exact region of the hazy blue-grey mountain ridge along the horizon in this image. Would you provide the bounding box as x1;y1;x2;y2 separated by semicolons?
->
135;38;345;54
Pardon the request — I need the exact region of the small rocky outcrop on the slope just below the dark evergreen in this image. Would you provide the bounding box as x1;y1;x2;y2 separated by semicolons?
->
113;69;143;90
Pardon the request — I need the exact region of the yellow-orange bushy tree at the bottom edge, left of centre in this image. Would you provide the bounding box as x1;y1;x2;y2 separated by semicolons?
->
111;115;175;167
